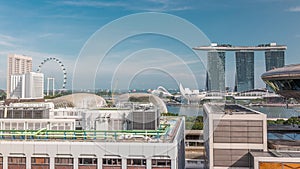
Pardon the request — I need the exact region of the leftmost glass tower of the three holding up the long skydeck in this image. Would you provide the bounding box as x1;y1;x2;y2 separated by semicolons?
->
206;52;225;91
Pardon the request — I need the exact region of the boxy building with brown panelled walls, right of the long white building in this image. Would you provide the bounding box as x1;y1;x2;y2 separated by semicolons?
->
203;103;267;169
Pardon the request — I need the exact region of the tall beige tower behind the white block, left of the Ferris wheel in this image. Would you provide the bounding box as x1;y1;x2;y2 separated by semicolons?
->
6;54;32;98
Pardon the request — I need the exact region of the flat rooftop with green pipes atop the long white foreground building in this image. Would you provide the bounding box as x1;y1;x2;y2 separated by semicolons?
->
0;117;183;143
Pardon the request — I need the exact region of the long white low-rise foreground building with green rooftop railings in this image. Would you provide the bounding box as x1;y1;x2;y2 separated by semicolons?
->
0;98;185;169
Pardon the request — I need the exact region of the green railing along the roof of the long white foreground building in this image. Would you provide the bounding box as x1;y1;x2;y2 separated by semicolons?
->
0;124;170;141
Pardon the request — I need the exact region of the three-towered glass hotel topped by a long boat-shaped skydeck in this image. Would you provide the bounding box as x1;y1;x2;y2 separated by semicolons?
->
193;43;287;92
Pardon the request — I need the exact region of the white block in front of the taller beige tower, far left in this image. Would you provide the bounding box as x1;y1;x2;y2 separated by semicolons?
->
9;72;44;99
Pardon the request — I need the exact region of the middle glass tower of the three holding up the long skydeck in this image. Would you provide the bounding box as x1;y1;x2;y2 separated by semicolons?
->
235;51;254;92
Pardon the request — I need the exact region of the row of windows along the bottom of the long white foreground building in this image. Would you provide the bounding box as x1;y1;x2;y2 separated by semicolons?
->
0;157;171;167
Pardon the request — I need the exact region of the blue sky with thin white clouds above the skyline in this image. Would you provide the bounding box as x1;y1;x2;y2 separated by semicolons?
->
0;0;300;92
